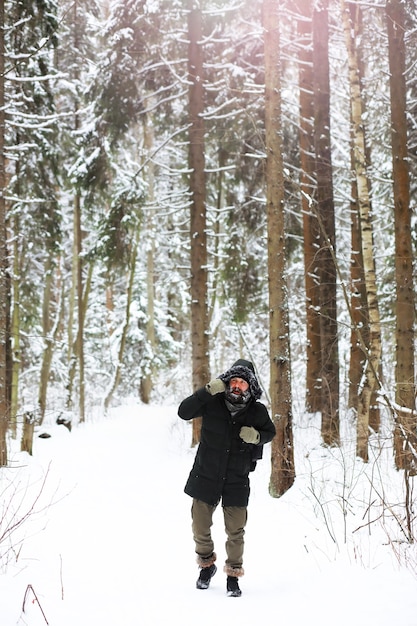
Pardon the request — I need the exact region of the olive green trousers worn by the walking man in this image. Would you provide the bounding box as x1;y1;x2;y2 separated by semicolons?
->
191;499;248;570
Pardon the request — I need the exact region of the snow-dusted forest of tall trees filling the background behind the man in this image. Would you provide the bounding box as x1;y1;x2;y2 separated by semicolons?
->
0;0;417;564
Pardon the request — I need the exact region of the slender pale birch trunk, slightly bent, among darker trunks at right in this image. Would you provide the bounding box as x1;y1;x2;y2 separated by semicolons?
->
341;0;381;461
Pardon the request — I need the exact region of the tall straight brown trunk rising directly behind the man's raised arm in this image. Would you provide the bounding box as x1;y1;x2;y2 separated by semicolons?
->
188;0;209;445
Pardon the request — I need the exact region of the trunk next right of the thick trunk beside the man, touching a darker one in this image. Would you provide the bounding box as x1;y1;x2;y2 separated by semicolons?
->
297;1;321;413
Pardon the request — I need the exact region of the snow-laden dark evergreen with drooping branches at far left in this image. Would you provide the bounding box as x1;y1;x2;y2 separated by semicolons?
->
5;1;61;448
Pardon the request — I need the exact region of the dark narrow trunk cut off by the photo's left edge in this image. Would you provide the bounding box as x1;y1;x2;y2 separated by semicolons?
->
0;2;10;467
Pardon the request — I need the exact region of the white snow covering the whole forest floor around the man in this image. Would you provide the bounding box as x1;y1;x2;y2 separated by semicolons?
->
0;405;417;626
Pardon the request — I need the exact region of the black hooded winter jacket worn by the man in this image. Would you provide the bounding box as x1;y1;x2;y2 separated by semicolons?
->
178;387;275;506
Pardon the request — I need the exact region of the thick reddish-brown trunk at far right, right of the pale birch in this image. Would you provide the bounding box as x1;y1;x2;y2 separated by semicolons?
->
386;0;417;470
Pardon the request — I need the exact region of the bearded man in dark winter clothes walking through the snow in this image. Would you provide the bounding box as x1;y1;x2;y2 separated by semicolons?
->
178;359;275;597
